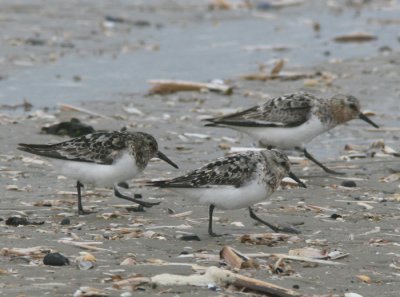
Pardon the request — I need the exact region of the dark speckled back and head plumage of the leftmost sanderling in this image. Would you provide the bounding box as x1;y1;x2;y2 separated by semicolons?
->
18;131;158;168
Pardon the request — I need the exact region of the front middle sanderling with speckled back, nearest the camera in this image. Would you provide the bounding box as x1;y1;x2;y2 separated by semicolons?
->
146;150;306;236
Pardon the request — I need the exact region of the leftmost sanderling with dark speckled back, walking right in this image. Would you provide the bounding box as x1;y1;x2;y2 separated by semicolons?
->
18;130;178;214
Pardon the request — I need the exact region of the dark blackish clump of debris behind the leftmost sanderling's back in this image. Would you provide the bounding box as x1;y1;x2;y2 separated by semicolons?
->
42;118;95;137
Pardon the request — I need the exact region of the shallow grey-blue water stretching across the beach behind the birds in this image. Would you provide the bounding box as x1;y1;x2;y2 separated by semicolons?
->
0;1;399;108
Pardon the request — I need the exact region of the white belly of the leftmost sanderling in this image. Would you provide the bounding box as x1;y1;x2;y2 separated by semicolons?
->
54;153;141;187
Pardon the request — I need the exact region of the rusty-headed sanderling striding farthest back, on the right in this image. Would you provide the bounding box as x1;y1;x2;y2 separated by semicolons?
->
206;92;378;174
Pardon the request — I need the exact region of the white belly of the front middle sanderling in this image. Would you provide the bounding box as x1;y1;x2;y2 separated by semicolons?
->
172;181;272;209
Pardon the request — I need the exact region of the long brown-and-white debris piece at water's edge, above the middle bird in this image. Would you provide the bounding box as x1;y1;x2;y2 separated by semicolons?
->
148;79;233;95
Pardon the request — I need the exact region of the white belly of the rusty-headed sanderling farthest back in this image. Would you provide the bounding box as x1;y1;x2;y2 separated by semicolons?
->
232;117;331;149
